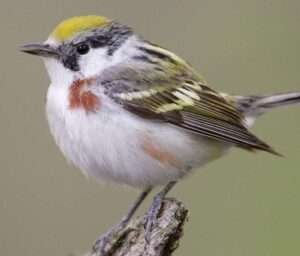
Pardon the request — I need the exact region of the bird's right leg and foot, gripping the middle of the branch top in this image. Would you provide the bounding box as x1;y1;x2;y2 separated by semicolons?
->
145;181;177;243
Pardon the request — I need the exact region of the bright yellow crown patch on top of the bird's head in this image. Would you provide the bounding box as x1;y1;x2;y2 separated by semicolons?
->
51;15;110;41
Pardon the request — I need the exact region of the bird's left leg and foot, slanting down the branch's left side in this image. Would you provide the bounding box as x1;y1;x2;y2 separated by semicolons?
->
93;187;152;255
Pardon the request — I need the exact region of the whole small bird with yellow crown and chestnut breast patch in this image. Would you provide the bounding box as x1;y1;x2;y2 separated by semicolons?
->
20;15;300;250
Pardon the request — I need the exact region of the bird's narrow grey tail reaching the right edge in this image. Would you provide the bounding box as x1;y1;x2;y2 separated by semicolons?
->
235;92;300;122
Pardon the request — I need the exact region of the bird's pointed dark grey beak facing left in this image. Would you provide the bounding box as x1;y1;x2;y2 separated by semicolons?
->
20;43;59;58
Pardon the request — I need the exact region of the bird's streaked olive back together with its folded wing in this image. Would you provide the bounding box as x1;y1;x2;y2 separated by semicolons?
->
106;45;277;154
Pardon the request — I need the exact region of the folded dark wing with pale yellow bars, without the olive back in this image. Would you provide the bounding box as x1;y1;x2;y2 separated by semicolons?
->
109;77;277;154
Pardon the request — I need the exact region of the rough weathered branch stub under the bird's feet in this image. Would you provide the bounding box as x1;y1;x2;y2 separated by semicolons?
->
86;198;188;256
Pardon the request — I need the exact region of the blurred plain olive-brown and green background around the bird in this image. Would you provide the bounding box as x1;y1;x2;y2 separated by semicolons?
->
0;0;300;256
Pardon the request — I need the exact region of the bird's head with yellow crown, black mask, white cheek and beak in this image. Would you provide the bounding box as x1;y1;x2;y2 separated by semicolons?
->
21;16;133;84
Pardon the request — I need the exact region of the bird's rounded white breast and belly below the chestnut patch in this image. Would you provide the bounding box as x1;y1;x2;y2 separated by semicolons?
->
47;85;228;187
